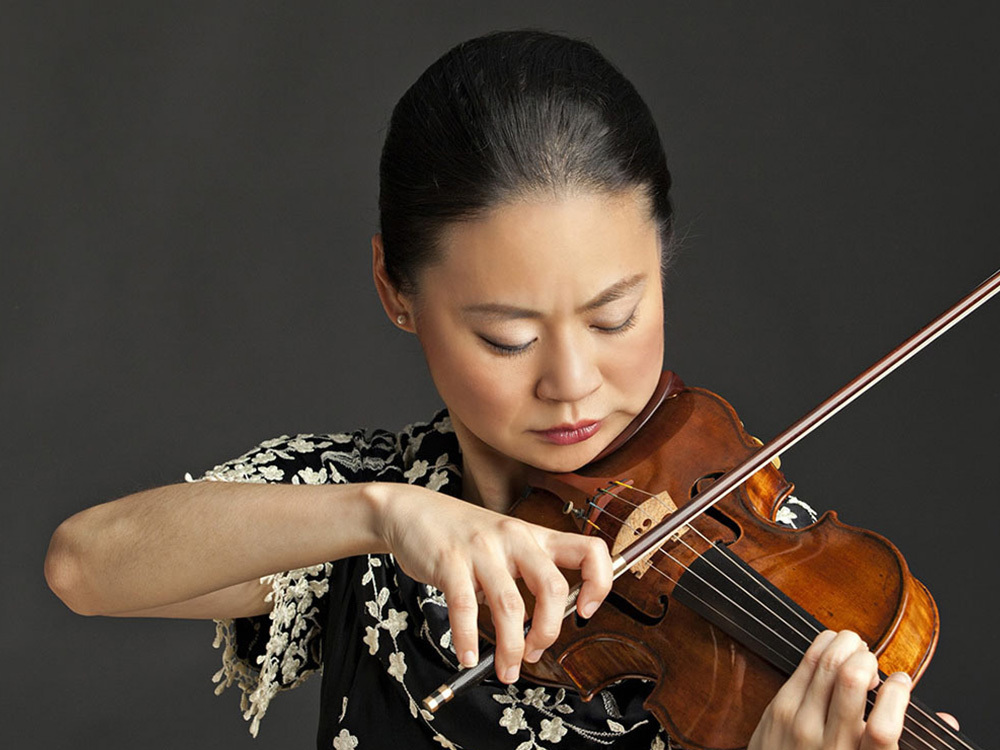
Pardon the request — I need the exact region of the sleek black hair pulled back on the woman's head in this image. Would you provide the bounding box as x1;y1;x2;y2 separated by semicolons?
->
379;31;673;292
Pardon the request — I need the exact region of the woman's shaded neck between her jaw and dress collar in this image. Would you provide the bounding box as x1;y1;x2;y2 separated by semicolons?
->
451;416;525;513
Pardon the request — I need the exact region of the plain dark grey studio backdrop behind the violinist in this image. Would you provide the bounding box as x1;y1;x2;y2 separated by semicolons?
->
0;1;1000;750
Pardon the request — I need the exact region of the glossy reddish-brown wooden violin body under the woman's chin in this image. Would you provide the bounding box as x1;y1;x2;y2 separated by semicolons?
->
480;373;939;748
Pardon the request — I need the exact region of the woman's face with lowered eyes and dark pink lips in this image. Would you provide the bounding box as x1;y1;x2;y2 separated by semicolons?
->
412;192;663;472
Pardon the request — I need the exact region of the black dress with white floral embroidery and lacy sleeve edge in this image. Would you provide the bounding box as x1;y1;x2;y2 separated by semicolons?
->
188;411;815;750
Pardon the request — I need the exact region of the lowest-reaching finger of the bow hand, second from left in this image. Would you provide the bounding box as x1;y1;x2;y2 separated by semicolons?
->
476;555;524;684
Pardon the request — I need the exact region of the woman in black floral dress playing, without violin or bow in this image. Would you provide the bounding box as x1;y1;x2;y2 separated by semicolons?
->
46;32;909;748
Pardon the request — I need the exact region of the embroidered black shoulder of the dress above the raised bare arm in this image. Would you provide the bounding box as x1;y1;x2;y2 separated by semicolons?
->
187;411;458;484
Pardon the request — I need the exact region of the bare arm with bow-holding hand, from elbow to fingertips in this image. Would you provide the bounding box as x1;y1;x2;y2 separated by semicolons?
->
45;482;611;682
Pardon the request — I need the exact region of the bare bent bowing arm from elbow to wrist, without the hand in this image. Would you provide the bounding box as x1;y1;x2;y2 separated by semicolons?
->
45;482;390;618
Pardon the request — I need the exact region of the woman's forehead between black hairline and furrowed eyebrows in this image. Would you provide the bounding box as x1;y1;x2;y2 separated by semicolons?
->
421;191;660;306
